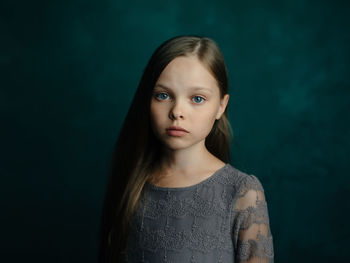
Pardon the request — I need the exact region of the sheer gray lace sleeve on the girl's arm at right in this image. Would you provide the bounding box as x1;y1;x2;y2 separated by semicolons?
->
233;175;274;263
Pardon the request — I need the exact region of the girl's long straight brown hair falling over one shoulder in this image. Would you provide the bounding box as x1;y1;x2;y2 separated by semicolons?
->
99;35;233;263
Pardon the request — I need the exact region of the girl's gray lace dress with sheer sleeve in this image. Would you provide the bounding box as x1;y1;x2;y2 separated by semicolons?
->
125;163;274;263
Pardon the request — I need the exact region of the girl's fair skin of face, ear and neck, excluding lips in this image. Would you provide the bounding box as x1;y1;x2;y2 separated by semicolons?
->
150;55;229;187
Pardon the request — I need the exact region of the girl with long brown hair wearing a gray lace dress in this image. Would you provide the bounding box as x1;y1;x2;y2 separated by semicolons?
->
99;36;274;263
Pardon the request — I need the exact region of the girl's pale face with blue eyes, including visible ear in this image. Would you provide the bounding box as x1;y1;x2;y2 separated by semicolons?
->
150;56;229;150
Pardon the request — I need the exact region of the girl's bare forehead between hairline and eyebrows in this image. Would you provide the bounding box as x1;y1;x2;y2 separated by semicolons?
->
155;56;218;92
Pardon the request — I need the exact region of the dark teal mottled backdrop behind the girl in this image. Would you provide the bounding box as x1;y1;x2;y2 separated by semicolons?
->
0;0;350;263
